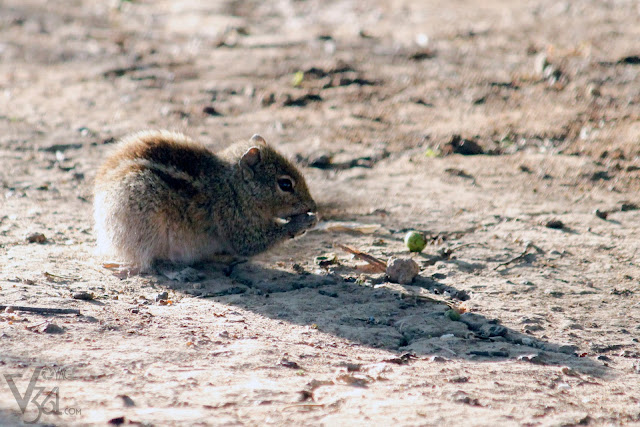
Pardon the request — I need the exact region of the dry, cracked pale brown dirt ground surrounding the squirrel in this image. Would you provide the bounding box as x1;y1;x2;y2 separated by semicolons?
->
0;0;640;426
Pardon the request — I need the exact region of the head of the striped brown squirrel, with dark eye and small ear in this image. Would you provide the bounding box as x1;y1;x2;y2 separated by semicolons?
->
232;135;317;220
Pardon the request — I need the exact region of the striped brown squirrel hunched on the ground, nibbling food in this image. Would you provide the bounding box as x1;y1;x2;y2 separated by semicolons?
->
94;131;318;271
